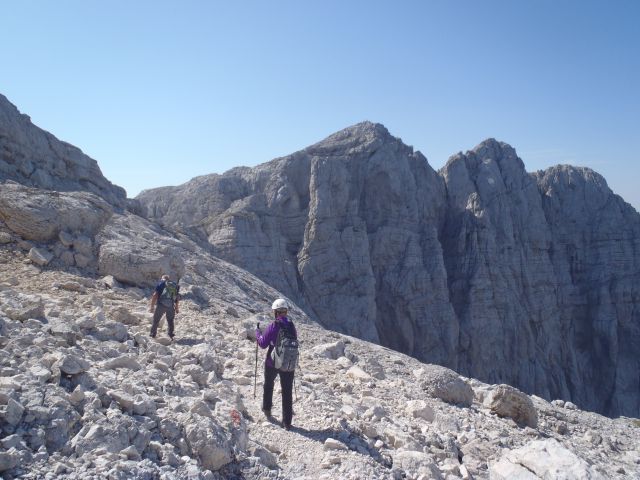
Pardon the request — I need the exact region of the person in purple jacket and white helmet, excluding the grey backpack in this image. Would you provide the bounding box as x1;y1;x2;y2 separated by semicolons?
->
256;298;298;430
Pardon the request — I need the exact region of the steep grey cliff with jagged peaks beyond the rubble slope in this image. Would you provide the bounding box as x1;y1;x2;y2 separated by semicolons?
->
138;122;640;416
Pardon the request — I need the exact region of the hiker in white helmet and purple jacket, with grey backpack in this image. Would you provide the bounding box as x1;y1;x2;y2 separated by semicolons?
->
256;298;298;430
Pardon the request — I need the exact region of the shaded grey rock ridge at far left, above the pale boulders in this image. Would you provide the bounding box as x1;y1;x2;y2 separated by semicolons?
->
0;94;126;207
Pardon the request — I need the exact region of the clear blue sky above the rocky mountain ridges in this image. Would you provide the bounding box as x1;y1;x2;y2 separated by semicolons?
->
0;0;640;209
